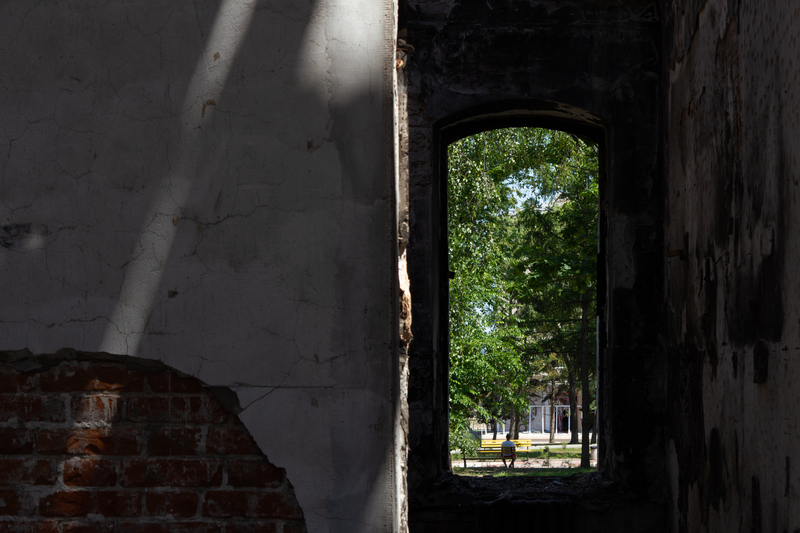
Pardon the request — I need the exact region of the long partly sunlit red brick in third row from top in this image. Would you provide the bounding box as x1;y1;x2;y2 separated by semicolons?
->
37;428;141;455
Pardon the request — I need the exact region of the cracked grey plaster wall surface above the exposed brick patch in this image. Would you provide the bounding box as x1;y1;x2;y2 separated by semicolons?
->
0;0;399;532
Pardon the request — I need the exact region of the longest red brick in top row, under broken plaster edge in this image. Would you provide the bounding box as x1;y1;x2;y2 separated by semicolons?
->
40;363;144;392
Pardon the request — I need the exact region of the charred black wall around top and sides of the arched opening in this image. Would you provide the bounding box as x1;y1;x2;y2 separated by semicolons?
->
406;0;666;515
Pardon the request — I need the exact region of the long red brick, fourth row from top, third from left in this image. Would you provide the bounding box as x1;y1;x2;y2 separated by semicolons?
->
120;459;222;487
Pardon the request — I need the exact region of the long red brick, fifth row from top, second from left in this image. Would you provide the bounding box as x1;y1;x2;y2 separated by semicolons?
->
39;491;142;518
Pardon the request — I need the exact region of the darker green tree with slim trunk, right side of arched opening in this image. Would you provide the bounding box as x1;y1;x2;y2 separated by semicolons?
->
517;167;598;465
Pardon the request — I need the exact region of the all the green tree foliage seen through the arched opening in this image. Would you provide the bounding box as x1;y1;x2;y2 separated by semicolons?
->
448;128;598;450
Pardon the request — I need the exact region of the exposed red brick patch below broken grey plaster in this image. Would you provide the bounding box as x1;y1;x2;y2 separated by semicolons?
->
0;361;305;533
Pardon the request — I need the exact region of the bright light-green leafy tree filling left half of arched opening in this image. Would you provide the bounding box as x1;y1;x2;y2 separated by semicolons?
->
448;130;526;432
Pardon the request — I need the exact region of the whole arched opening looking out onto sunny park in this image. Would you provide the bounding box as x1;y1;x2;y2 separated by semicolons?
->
441;127;602;476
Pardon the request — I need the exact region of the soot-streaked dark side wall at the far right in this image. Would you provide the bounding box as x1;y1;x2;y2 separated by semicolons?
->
664;0;800;532
